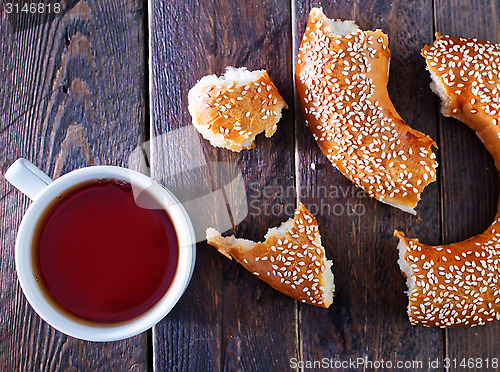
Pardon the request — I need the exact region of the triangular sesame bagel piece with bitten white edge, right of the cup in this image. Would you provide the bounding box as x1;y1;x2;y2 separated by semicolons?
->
207;203;335;308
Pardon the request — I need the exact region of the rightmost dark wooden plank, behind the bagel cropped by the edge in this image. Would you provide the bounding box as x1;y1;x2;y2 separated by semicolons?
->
434;0;500;370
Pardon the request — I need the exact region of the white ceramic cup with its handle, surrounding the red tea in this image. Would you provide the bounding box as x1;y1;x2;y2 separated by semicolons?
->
5;159;196;341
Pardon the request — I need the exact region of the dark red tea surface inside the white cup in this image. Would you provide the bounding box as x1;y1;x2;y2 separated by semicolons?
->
34;180;178;322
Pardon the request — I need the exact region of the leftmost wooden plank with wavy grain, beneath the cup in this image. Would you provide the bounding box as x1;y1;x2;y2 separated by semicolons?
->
0;0;148;371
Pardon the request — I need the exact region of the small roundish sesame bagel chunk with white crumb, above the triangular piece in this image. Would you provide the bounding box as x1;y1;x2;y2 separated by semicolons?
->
188;66;288;152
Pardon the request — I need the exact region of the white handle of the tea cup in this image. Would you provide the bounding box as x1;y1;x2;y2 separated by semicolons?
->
5;158;52;200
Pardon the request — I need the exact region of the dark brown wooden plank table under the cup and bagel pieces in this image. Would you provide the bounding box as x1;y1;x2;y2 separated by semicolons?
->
0;0;500;371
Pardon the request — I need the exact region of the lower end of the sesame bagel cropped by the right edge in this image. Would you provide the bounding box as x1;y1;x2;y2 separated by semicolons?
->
394;228;500;327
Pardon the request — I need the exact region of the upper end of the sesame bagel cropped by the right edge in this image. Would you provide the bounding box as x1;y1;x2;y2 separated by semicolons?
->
422;33;500;168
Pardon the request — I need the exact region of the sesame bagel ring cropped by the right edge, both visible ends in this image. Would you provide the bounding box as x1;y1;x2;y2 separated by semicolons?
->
394;34;500;327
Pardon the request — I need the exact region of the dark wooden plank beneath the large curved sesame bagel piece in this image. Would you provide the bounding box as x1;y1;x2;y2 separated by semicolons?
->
293;1;443;370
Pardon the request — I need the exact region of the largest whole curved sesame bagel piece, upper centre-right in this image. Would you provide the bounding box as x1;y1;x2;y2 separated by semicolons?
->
295;8;437;214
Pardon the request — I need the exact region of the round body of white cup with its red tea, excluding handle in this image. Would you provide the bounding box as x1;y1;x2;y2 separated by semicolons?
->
16;167;194;341
